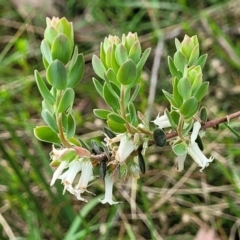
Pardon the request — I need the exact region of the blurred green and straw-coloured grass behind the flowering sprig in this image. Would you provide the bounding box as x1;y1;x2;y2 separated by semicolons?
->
0;0;240;240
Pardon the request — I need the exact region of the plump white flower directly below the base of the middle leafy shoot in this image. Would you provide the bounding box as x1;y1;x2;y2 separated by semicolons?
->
116;135;137;163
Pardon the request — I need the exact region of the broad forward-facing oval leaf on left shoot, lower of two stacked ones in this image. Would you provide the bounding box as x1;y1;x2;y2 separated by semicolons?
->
46;60;67;90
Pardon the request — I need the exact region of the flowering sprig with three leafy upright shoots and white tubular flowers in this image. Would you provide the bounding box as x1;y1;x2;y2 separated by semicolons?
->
34;18;239;204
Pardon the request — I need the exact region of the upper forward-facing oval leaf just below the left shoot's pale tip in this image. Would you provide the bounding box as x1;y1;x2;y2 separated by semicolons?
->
51;33;72;64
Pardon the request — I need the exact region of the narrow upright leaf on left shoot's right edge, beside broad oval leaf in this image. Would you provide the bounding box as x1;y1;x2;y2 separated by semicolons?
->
67;54;85;88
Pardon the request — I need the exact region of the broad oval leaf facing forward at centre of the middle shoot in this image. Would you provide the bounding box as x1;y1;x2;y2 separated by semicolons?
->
117;59;137;85
